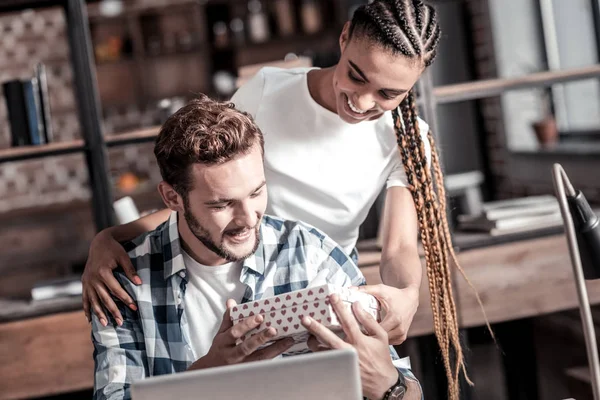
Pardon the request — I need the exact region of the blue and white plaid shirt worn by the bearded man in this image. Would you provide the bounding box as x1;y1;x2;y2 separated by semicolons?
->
92;212;414;400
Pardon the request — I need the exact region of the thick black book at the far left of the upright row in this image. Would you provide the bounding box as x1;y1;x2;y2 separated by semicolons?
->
2;79;31;147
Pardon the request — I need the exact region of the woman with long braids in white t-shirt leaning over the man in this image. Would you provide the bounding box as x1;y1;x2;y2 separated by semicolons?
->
82;0;463;399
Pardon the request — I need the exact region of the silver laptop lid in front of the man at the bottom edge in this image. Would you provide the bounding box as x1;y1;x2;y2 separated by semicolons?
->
131;349;362;400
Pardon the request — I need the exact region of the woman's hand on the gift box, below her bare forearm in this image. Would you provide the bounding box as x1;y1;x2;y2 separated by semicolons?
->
358;284;419;345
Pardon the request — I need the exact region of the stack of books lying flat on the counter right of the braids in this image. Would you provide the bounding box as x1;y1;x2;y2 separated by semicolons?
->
458;195;562;236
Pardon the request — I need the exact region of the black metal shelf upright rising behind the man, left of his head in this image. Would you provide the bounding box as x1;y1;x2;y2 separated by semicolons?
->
65;0;114;230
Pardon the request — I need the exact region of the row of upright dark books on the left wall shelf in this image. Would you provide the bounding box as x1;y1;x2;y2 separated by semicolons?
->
2;64;52;147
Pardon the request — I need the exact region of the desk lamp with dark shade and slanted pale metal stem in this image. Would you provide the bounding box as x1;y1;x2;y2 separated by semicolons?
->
552;164;600;400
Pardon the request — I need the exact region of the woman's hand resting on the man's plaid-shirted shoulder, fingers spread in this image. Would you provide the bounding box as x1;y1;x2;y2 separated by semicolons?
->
81;230;142;326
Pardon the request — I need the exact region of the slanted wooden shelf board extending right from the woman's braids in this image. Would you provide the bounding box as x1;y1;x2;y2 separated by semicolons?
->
433;64;600;104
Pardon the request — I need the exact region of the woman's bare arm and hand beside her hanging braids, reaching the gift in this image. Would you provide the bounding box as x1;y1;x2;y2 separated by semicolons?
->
360;187;423;345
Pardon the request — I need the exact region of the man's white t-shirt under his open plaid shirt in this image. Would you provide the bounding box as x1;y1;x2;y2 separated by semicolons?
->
182;251;246;359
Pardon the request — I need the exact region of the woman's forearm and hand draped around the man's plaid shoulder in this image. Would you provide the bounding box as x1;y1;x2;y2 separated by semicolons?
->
81;209;171;325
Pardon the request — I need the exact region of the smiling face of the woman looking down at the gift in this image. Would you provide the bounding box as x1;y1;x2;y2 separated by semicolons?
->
333;24;424;124
